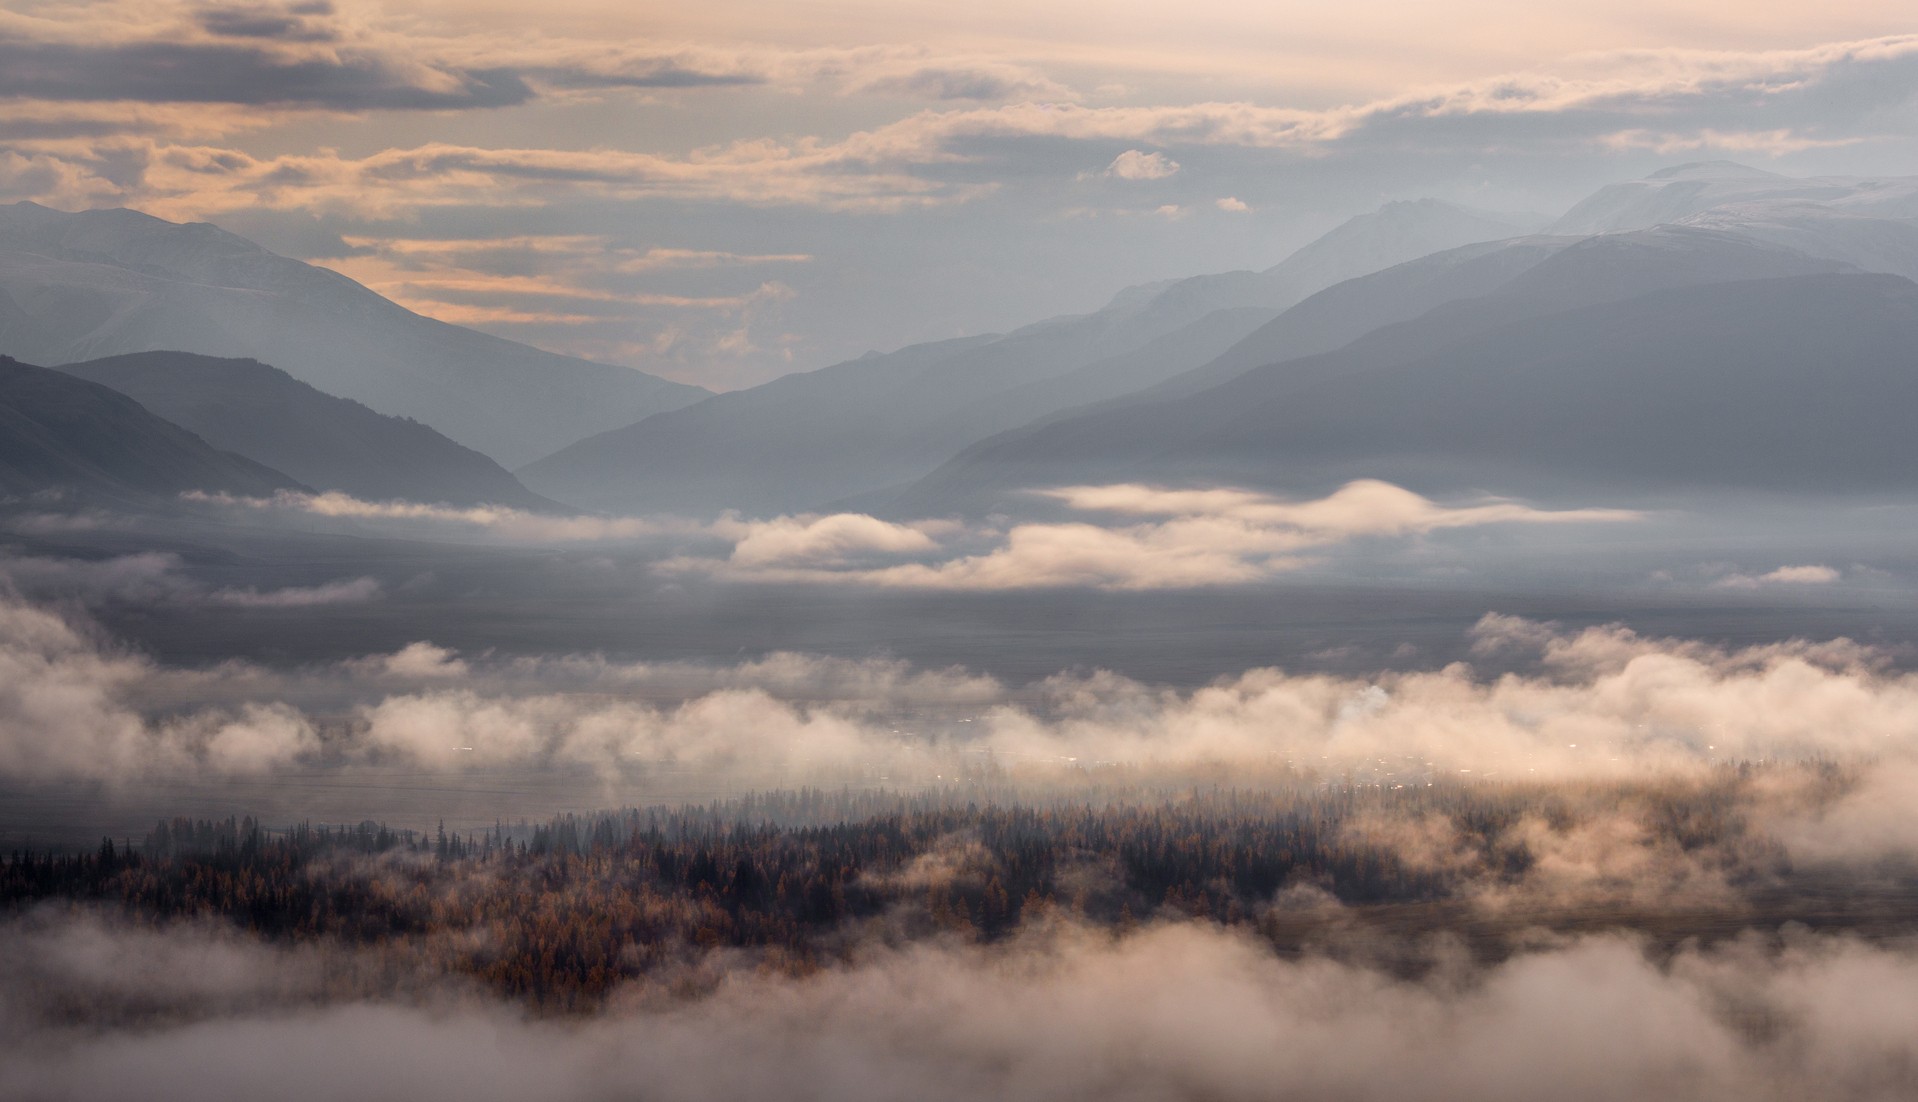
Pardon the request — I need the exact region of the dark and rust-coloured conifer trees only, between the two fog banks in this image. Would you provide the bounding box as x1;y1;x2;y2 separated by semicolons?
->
0;770;1856;1010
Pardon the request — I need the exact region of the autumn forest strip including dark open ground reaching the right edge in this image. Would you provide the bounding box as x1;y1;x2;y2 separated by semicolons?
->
0;763;1918;1014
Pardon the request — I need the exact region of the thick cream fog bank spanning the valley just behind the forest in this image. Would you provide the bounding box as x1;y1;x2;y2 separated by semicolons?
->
11;574;1918;797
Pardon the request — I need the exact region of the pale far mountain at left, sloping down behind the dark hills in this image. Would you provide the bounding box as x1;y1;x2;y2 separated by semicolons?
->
0;203;706;464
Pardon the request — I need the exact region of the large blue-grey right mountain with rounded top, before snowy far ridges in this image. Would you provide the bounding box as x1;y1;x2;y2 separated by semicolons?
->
888;226;1871;516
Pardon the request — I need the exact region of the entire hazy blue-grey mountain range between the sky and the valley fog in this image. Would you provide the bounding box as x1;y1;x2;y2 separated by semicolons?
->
0;163;1918;517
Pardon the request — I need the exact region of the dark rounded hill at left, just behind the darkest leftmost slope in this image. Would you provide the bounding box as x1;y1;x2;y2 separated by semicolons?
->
58;353;560;510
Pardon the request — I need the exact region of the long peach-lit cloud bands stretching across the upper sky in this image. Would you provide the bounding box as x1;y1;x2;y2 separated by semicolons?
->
14;31;1918;231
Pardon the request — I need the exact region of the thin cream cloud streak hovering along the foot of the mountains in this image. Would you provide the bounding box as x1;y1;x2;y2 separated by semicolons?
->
186;481;1640;590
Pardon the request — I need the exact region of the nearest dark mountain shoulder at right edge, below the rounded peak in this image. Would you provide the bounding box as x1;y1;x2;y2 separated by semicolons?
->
1153;274;1918;494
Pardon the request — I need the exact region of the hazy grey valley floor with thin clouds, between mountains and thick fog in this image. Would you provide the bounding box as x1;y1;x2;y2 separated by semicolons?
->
0;483;1918;686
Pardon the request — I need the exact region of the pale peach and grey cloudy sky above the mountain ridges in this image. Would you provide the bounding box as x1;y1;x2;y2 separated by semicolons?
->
0;0;1918;389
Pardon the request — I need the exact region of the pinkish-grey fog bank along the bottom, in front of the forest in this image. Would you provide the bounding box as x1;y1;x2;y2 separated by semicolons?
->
11;916;1918;1102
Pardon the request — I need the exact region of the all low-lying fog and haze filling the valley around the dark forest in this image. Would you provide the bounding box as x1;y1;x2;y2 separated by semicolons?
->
11;487;1918;1100
